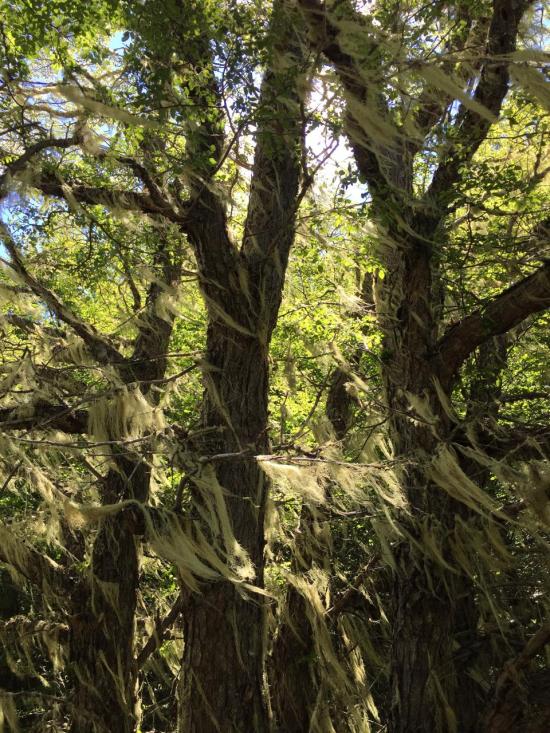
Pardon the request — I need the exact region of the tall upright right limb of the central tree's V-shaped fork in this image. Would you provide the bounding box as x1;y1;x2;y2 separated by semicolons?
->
242;2;307;329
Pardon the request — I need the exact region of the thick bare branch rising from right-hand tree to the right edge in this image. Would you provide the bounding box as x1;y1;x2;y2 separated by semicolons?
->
435;262;550;389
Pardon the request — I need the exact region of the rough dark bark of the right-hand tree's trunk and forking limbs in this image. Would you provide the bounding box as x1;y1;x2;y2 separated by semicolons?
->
299;0;548;733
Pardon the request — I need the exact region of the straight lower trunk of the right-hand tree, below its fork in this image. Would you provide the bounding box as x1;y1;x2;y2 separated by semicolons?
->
377;236;468;733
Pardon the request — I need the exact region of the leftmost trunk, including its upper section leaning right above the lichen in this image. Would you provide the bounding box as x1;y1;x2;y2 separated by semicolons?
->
68;294;179;733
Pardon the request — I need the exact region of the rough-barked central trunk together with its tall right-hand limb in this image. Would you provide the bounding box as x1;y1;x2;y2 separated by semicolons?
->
178;2;303;733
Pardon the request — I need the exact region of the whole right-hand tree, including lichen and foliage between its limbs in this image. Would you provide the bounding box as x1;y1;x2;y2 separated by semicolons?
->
300;0;550;732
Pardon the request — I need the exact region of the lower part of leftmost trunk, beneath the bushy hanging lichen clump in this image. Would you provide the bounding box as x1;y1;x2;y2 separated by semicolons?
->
68;461;150;733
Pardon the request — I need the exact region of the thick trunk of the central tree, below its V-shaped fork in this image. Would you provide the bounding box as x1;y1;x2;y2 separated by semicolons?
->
179;323;268;733
